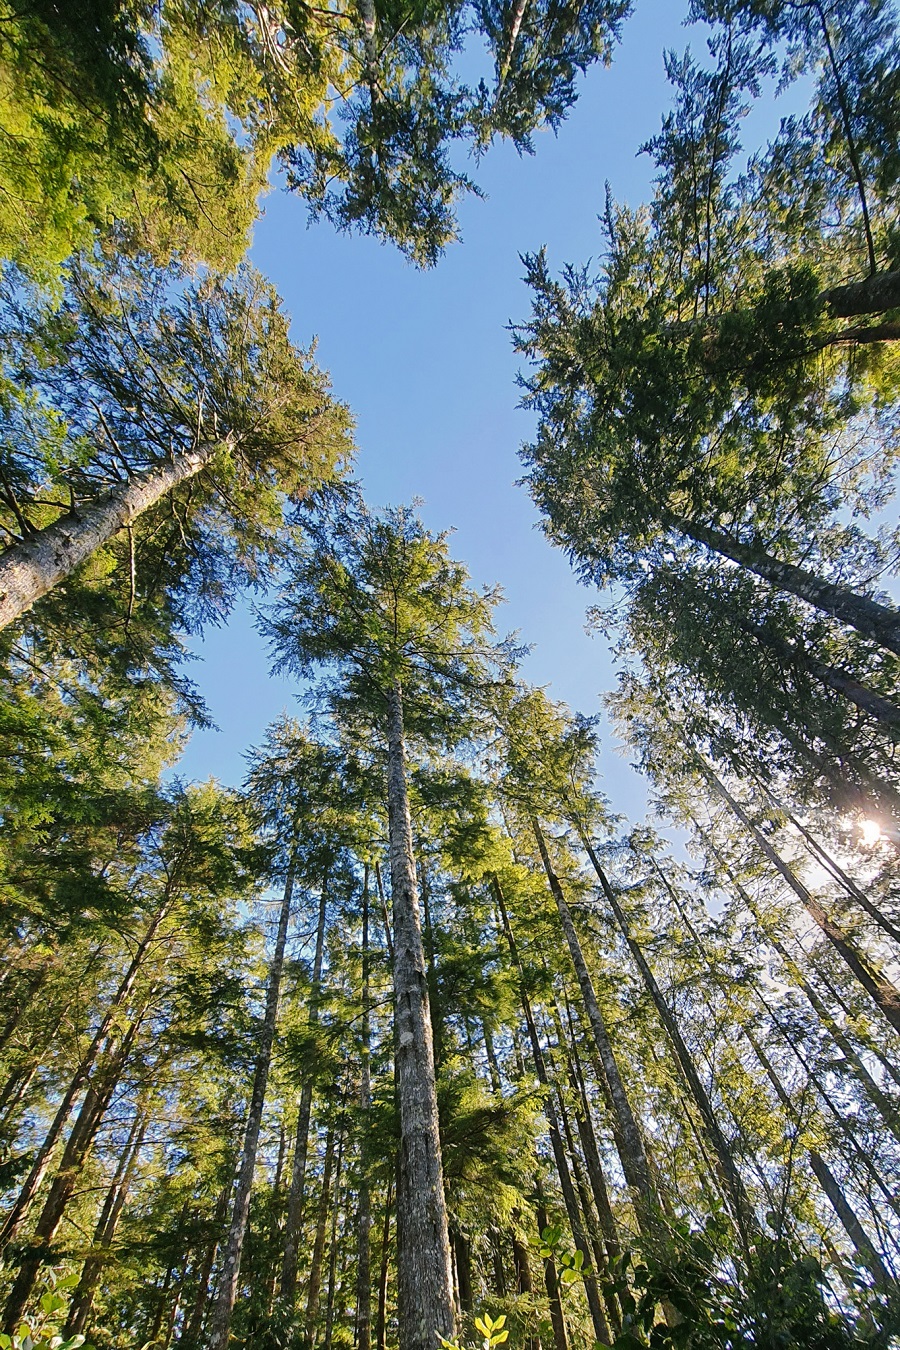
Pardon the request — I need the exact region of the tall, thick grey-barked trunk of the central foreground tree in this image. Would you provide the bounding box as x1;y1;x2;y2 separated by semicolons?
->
387;682;456;1350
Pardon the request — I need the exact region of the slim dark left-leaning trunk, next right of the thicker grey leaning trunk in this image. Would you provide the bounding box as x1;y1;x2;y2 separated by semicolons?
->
579;826;757;1251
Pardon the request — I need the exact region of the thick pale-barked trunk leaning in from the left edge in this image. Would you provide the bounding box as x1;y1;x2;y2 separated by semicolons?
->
0;444;220;628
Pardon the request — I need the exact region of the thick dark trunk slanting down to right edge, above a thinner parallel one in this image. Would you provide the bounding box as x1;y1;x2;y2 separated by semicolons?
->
669;516;900;655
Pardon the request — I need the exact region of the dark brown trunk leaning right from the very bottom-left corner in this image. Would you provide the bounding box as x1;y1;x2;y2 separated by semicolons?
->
3;995;152;1335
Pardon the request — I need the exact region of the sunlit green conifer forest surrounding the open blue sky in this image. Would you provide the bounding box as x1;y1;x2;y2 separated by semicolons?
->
0;0;900;1350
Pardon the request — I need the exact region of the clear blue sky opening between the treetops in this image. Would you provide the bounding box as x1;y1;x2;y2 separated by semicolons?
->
172;0;793;819
